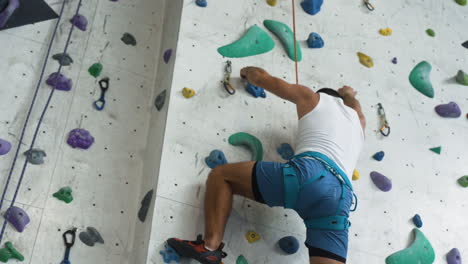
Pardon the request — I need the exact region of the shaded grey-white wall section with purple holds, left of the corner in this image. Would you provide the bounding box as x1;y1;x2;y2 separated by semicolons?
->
0;0;168;264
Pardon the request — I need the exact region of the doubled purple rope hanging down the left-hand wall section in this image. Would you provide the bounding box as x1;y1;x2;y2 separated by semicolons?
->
0;0;82;242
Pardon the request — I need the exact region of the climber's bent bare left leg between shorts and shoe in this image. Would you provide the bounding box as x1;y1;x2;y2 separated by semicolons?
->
205;161;255;249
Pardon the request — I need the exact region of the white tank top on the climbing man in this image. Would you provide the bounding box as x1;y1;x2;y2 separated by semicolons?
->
296;93;364;177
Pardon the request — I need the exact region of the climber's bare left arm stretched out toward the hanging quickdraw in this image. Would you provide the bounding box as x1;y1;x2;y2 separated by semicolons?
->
241;67;319;118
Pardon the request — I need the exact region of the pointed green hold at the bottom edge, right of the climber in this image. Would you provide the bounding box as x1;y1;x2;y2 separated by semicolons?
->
385;228;435;264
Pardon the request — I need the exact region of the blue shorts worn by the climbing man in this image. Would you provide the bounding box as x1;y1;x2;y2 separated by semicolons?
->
252;158;353;262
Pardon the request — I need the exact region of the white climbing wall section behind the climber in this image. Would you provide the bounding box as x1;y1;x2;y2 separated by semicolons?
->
147;0;468;263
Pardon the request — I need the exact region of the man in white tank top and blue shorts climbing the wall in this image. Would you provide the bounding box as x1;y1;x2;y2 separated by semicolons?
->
167;67;365;264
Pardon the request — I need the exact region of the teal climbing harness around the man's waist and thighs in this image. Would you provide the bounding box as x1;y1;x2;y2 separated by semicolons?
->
283;152;357;230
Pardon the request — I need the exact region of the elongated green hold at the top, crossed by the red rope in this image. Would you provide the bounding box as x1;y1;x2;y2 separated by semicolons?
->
263;20;302;61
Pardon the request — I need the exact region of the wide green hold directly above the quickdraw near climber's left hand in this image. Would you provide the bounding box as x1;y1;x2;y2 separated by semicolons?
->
218;25;275;58
